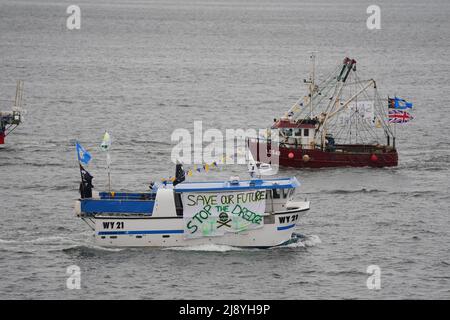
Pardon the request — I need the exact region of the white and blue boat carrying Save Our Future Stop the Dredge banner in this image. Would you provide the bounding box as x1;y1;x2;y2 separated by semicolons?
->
75;160;309;248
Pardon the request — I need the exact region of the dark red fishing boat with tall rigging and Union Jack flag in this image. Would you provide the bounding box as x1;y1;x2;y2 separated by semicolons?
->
248;54;412;168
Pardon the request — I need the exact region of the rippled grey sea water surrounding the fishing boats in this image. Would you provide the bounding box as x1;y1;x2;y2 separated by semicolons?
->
0;0;450;299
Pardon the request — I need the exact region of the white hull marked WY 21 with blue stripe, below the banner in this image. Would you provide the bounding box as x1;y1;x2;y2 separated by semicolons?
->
83;203;309;248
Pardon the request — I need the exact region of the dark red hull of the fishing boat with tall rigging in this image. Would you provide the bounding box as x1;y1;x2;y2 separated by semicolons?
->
249;141;398;168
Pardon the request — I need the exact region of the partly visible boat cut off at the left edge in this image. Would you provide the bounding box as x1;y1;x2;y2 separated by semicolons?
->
0;81;23;145
